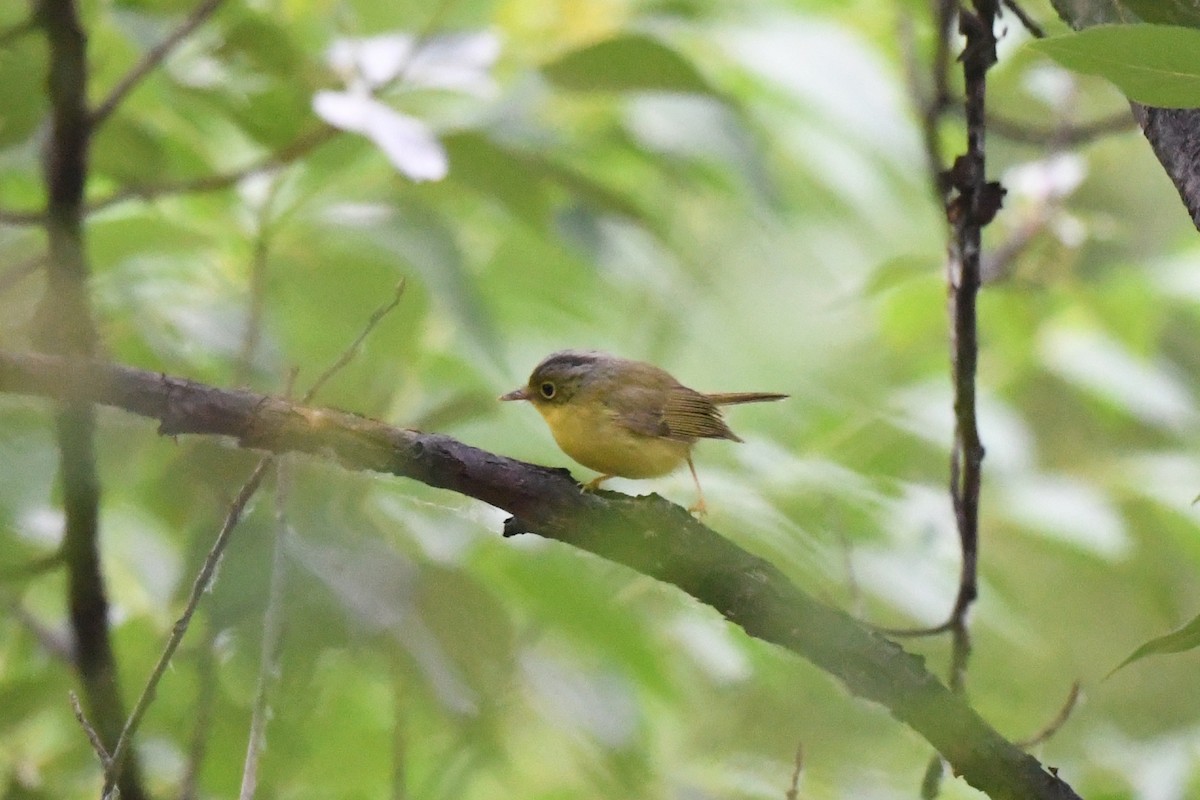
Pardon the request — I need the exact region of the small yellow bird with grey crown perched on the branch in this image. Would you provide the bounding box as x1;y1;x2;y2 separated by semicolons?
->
500;350;787;515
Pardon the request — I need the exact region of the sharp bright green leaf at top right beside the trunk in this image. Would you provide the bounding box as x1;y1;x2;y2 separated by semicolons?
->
1031;25;1200;108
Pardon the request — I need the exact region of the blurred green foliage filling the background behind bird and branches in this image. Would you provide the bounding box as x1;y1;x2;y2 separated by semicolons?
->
7;0;1200;800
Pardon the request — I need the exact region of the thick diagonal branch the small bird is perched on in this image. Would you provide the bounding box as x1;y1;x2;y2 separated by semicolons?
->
0;353;1079;800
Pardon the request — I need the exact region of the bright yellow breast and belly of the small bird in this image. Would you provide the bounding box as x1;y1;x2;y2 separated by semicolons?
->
536;403;691;477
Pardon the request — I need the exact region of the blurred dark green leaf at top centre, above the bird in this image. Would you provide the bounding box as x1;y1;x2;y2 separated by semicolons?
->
542;35;716;95
